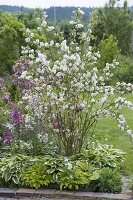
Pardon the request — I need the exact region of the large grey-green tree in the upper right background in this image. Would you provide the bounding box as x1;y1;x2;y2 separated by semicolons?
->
91;1;133;55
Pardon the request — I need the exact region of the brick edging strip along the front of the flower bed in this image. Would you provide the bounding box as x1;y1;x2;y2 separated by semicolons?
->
0;188;133;200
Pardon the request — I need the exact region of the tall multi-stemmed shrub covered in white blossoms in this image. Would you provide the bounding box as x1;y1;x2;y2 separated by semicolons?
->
0;9;133;156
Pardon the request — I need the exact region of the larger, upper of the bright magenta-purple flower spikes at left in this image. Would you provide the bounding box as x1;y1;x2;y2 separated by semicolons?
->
11;105;22;127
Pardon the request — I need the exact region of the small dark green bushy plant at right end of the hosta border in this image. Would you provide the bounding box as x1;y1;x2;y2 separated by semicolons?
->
93;168;122;193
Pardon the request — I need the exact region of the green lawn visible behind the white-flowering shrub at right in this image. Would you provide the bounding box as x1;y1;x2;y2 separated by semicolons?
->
96;94;133;175
